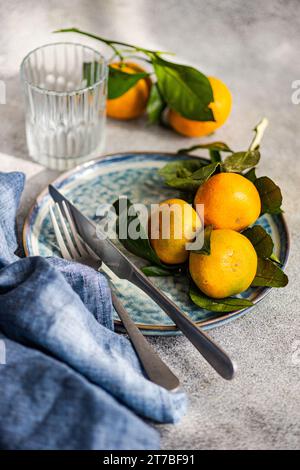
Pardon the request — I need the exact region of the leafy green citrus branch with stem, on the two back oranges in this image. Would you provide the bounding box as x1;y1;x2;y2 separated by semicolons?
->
54;28;214;122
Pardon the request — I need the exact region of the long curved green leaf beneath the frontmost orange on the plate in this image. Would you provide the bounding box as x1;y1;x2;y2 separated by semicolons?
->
189;285;253;312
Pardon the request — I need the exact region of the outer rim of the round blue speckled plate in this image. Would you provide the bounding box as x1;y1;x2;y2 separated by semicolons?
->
22;150;290;335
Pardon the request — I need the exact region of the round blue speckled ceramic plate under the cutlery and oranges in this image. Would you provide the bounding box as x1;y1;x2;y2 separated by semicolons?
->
23;152;289;335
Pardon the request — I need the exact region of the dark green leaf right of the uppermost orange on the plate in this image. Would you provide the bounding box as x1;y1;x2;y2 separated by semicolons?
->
254;176;282;214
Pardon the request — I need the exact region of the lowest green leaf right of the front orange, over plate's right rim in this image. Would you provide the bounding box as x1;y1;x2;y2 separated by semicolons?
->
251;258;289;287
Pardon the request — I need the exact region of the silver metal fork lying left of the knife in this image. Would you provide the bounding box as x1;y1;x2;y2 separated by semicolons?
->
50;202;180;390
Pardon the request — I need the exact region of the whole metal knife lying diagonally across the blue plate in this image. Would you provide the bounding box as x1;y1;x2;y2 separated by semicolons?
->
49;185;236;380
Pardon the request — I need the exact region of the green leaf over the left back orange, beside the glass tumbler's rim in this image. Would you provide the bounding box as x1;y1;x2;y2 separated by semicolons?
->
108;66;149;100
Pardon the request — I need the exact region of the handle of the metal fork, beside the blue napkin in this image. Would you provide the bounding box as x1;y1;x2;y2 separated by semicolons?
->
111;291;180;391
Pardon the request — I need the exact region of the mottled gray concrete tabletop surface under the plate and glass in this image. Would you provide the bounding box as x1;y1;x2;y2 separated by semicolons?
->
0;0;300;449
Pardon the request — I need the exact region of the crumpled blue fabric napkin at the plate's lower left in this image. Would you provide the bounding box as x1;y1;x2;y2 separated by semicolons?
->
0;172;186;450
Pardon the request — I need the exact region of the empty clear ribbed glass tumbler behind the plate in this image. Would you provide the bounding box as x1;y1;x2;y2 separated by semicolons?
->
21;43;108;170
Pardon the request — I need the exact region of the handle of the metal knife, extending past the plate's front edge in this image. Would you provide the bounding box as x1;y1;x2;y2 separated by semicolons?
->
130;269;235;380
